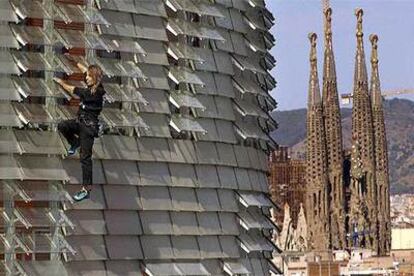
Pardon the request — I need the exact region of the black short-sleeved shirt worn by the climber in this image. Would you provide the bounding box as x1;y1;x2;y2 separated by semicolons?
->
73;84;105;120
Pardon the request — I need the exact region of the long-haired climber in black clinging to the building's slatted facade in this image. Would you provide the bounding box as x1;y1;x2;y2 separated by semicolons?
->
53;63;105;201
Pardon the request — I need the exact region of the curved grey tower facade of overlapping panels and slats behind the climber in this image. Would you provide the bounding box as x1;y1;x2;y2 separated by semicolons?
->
0;0;277;276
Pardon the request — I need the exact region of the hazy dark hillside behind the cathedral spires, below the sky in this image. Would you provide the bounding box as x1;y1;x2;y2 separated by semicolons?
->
272;99;414;194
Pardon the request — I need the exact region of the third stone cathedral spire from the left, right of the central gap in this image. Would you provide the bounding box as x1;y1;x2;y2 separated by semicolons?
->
348;9;378;251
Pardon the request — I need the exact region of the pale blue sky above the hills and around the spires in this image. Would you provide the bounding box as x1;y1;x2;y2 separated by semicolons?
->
266;0;414;110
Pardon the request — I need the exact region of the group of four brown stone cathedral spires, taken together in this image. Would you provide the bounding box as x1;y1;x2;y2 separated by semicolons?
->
305;8;391;255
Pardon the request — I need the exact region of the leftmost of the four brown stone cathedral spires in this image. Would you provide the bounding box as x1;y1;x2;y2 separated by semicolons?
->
306;33;330;250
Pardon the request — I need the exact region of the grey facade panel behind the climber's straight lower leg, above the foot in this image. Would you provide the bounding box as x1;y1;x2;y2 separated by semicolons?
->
62;158;106;184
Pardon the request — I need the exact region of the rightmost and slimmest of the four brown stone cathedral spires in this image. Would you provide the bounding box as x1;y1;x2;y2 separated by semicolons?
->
370;35;391;255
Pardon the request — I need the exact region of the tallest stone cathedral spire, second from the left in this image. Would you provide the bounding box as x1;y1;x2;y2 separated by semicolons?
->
322;8;346;249
